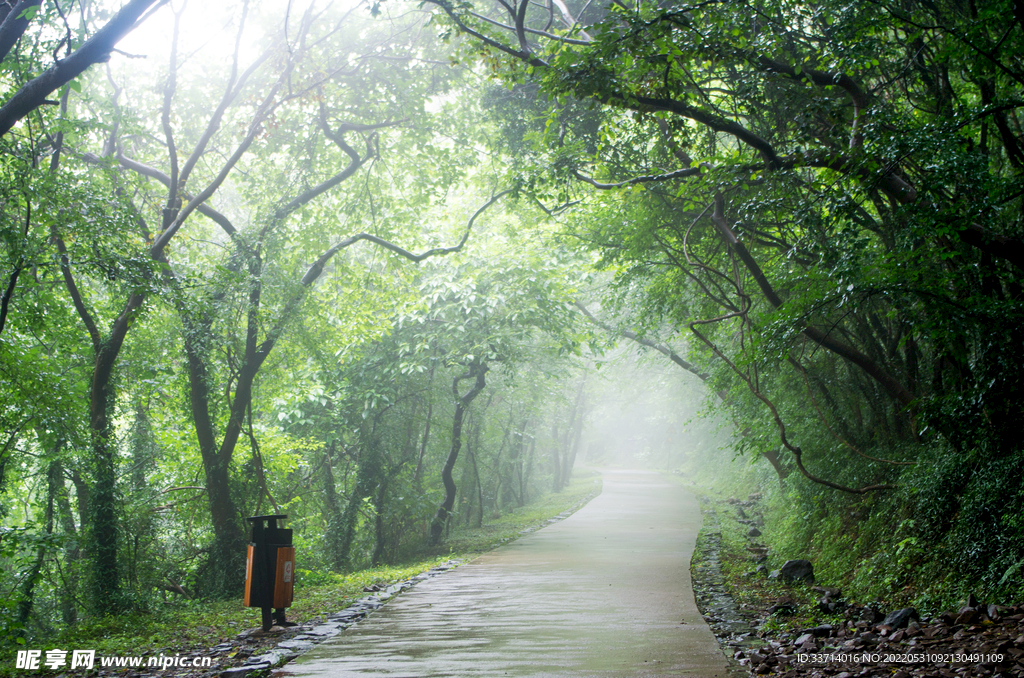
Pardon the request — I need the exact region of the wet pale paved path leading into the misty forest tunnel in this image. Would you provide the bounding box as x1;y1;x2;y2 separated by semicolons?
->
285;470;726;678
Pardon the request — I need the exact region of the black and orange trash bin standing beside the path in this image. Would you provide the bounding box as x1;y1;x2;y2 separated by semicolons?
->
245;514;295;631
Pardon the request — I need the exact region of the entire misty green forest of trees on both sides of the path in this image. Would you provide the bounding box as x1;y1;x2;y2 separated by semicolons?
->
0;0;1024;655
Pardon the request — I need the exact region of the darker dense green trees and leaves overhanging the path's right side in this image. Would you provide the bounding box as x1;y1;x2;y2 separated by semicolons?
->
430;0;1024;595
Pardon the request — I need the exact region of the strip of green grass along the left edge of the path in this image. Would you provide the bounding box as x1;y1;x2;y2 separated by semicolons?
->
0;470;601;676
